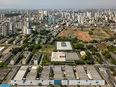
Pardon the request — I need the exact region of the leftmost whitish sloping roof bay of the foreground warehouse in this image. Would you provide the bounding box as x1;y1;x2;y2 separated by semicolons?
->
14;66;28;80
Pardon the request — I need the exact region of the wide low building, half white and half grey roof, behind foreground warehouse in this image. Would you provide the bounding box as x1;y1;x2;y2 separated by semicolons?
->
51;52;81;62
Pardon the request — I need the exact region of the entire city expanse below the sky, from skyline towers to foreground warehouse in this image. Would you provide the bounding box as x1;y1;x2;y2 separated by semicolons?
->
0;9;116;87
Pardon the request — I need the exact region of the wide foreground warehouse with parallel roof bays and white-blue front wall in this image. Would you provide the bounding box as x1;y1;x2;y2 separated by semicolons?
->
11;65;105;85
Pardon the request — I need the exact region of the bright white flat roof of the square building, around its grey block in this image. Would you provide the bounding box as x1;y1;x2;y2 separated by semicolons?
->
56;41;73;50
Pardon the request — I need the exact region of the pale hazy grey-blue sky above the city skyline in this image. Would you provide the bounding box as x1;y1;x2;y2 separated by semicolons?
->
0;0;116;9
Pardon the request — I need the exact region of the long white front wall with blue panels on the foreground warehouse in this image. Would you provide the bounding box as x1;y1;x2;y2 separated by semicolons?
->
11;80;105;85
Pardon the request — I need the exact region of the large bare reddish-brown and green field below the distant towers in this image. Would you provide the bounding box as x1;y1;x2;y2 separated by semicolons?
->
58;28;114;41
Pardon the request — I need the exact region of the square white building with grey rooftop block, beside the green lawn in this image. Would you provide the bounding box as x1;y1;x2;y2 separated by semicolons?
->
56;41;73;51
